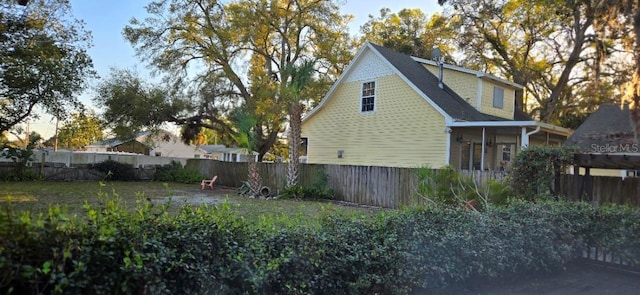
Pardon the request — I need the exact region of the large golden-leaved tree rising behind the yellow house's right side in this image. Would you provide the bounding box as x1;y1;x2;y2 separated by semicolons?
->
439;0;626;123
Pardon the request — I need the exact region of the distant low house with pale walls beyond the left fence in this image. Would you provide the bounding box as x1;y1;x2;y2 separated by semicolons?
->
85;130;206;158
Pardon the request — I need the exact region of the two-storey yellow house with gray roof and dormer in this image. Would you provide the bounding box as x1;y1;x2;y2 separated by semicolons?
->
302;43;571;170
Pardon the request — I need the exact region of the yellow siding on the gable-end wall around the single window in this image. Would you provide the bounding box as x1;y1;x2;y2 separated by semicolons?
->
302;75;448;168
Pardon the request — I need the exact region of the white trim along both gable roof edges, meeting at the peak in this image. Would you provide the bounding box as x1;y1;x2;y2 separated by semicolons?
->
302;41;453;121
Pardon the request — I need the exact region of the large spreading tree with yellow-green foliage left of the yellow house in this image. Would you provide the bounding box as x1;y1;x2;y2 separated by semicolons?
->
117;0;353;158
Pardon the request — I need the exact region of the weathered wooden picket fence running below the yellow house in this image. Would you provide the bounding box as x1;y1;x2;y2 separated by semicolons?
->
187;159;504;208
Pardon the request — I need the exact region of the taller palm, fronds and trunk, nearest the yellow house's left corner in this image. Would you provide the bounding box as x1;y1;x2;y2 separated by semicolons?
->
283;61;314;187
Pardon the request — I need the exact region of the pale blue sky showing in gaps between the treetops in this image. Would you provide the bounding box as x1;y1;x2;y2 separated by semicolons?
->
29;0;442;139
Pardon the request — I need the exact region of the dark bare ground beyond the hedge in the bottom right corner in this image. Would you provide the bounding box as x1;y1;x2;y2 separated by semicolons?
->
416;263;640;295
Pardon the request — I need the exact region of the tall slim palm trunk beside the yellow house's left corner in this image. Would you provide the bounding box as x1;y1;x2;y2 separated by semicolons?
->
287;102;303;187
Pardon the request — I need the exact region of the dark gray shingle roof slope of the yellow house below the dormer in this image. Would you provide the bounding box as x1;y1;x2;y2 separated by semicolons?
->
370;43;532;121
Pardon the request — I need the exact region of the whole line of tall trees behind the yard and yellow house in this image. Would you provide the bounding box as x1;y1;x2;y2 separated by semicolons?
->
0;0;640;158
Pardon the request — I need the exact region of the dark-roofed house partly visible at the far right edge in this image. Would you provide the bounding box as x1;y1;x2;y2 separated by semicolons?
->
564;104;640;177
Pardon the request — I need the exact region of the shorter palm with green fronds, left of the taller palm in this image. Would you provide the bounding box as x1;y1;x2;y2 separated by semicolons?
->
231;110;262;197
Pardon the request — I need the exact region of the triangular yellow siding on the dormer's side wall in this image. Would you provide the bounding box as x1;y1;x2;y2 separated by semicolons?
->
422;64;479;110
